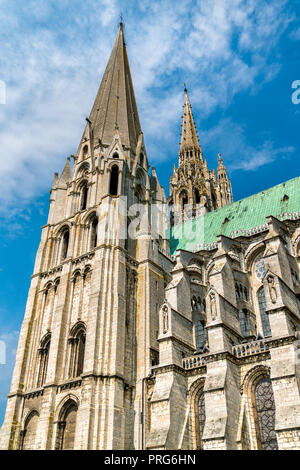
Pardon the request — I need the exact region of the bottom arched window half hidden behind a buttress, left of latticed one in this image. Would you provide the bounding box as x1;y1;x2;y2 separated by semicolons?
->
188;377;205;450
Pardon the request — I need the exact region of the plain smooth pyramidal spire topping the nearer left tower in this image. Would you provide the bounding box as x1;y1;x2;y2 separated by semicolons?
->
83;22;141;152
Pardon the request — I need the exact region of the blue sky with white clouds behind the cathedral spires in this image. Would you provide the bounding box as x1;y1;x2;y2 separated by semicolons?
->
0;0;300;424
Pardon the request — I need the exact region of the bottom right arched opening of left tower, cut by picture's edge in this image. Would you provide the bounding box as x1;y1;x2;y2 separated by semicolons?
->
55;400;78;450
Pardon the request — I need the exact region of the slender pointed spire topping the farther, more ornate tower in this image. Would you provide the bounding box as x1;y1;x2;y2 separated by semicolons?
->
180;87;201;151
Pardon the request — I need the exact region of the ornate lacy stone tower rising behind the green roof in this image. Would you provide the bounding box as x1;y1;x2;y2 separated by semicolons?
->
170;88;233;222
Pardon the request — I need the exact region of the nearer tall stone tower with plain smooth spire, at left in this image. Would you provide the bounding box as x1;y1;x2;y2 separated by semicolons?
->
1;24;171;449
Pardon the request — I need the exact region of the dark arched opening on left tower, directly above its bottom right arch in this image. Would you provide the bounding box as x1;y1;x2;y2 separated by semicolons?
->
69;323;85;378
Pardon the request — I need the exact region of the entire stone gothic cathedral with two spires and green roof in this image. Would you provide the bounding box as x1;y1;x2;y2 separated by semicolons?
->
0;23;300;450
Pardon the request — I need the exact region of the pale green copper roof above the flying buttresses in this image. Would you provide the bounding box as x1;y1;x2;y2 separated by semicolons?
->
170;177;300;253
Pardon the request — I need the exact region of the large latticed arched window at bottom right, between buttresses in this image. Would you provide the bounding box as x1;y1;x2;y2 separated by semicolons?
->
254;377;278;450
